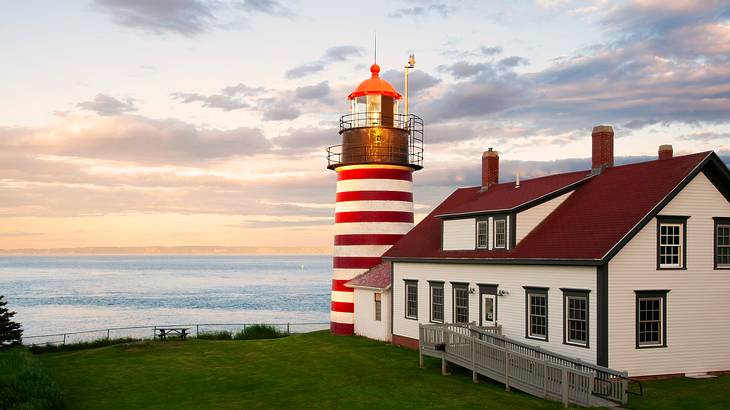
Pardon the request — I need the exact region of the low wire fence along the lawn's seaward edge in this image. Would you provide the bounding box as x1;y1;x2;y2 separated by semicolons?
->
23;322;330;346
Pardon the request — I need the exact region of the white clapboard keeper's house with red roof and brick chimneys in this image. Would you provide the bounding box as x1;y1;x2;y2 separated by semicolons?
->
354;126;730;376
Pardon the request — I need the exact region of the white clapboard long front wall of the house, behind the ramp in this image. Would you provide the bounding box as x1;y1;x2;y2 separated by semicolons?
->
392;262;596;363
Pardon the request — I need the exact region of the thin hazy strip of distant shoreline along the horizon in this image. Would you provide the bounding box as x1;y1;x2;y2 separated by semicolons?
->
0;246;332;256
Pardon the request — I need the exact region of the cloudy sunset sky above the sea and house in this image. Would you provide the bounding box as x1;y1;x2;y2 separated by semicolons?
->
0;0;730;249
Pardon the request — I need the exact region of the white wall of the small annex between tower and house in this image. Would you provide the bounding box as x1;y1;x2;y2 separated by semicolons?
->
355;288;390;342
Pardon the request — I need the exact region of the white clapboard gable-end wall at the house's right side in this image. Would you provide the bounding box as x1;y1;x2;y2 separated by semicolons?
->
608;174;730;376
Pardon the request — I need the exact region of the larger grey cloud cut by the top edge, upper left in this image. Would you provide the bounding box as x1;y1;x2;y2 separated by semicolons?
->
93;0;216;36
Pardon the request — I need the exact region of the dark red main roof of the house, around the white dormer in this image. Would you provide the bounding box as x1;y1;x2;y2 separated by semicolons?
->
383;152;712;261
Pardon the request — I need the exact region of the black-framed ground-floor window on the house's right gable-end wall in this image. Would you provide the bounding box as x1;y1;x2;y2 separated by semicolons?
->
636;290;668;348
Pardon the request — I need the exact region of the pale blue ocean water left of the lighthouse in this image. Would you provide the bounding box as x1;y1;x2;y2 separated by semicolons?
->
0;256;332;336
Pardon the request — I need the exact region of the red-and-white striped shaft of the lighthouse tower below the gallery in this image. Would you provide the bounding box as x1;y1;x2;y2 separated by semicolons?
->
330;164;413;334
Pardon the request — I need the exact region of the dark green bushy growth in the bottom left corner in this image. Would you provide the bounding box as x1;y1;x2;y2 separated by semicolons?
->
0;347;63;410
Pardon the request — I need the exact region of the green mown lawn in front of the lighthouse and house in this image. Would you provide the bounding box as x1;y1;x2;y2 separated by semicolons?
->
32;332;730;409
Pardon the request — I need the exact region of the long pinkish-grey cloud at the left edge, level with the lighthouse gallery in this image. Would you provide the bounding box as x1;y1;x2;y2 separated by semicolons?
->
0;115;270;164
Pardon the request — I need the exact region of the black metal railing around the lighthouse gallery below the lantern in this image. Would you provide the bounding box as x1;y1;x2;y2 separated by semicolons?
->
327;112;423;168
